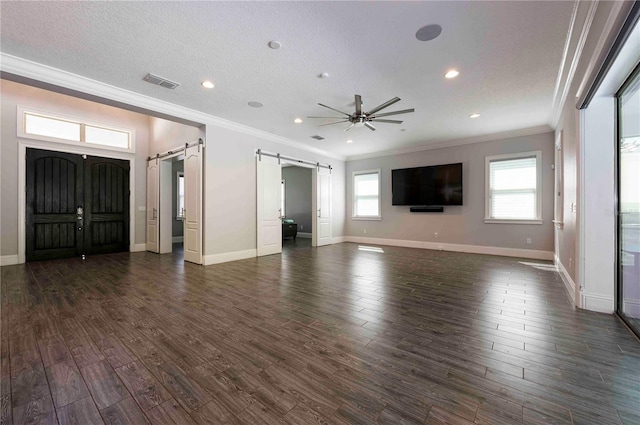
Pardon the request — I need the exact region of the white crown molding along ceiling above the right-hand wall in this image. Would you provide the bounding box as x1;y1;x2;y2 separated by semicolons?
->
549;0;598;128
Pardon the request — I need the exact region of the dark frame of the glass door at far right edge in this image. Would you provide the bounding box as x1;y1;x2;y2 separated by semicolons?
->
614;63;640;338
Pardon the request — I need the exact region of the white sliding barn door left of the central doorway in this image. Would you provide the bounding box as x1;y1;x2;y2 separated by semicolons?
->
256;156;282;257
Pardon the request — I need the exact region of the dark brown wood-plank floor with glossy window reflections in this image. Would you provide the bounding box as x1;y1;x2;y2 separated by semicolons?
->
0;239;640;425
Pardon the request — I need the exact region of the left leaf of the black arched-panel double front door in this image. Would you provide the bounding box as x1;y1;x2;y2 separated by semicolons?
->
25;149;84;261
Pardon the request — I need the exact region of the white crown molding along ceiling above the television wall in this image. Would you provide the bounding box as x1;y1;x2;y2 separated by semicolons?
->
347;125;553;162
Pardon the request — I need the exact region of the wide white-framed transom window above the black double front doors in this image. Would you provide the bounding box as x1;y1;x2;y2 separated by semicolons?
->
18;107;133;150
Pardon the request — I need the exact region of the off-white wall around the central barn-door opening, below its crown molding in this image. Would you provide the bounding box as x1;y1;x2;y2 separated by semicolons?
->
204;123;345;264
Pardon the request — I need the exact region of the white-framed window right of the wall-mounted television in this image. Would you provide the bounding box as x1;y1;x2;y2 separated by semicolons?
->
485;151;542;224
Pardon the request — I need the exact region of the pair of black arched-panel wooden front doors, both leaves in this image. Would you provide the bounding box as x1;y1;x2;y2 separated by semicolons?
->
26;149;129;261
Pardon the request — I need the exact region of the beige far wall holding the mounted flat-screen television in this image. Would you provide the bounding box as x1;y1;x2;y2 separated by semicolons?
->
346;132;554;258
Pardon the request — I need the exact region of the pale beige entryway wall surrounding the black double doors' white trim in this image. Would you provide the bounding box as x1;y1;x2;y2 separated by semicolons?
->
0;79;149;257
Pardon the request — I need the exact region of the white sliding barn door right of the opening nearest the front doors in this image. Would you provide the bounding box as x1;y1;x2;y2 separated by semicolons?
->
183;145;203;264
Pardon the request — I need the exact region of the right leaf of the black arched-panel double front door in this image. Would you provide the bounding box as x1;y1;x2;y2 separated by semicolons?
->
85;157;129;254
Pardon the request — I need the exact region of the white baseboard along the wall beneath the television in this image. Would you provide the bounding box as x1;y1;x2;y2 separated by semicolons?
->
345;236;553;261
